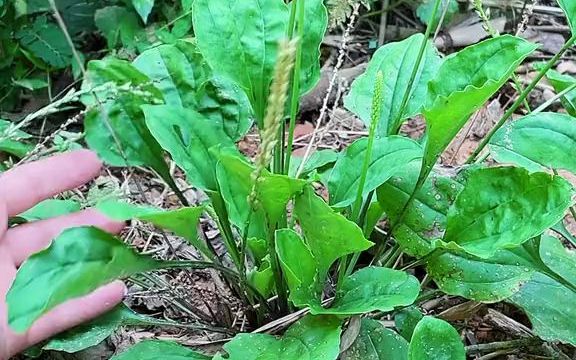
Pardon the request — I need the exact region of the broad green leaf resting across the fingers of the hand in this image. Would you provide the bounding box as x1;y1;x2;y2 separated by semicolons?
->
6;227;162;333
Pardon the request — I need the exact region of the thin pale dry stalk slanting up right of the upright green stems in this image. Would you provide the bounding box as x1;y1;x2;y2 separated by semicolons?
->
296;4;360;178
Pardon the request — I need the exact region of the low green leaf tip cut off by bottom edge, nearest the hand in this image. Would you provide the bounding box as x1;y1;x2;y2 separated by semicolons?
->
111;340;211;360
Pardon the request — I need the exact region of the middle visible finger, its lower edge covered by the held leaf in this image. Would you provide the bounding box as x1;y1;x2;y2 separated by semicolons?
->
2;209;125;266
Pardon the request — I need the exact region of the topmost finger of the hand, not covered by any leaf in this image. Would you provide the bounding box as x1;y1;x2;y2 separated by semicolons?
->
0;150;102;216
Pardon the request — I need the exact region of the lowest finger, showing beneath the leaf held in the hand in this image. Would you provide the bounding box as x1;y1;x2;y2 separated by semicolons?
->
18;281;126;351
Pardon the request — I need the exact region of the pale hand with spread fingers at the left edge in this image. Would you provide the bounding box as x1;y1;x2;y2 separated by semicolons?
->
0;150;126;360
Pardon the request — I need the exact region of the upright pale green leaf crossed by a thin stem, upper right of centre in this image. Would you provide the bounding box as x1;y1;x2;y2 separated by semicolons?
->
344;34;441;136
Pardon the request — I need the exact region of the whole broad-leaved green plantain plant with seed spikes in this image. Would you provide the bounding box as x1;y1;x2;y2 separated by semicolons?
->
7;0;576;360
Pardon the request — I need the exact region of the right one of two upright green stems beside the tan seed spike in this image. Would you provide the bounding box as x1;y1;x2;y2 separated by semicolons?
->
284;0;306;174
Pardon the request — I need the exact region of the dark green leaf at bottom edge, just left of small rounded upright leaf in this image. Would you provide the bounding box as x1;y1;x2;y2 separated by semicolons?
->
341;318;408;360
